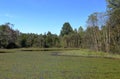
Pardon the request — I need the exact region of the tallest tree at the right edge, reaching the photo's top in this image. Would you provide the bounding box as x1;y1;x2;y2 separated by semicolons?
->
107;0;120;52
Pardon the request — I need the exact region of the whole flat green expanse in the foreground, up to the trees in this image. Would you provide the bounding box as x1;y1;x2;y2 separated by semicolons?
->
0;50;120;79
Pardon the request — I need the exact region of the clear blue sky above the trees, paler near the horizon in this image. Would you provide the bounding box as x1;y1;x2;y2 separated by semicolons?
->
0;0;106;34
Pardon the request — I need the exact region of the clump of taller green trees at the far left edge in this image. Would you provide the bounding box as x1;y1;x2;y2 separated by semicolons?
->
0;23;18;48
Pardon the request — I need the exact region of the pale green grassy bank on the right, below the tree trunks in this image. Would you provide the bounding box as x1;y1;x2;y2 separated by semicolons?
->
59;49;120;59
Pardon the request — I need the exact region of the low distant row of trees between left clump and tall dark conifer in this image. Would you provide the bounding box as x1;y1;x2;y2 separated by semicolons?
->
19;32;60;48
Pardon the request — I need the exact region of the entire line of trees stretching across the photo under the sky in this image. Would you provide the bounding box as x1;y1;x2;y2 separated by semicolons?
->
0;0;120;53
